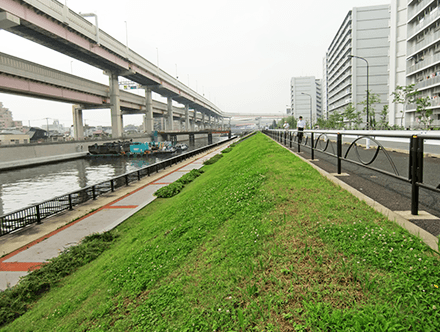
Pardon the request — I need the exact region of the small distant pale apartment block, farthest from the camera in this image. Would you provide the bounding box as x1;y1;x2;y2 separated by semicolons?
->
290;76;322;123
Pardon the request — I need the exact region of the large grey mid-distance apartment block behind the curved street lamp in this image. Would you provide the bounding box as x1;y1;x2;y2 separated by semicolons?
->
323;5;390;125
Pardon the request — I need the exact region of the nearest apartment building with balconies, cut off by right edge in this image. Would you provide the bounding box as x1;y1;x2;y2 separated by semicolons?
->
404;0;440;127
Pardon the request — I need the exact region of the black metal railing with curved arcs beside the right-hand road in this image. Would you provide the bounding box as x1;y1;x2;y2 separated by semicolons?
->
263;130;440;215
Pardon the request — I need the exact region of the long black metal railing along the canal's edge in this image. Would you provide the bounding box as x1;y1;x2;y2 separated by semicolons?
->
0;137;235;236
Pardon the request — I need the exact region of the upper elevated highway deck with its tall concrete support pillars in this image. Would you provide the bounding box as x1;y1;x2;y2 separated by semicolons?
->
0;0;223;137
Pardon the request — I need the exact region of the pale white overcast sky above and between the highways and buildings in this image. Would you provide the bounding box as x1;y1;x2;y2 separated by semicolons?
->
0;0;389;126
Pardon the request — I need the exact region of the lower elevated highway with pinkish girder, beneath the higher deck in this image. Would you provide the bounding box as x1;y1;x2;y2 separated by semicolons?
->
0;52;223;139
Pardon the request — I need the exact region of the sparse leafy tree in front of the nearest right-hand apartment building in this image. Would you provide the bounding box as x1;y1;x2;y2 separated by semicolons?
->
391;84;433;129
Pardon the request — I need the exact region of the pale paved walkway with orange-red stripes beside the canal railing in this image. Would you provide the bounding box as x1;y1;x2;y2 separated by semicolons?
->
0;142;232;290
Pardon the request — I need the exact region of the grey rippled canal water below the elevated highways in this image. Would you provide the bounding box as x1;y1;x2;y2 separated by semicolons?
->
0;136;226;216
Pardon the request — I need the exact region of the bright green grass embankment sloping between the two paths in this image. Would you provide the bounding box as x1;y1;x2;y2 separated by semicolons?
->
4;134;440;331
